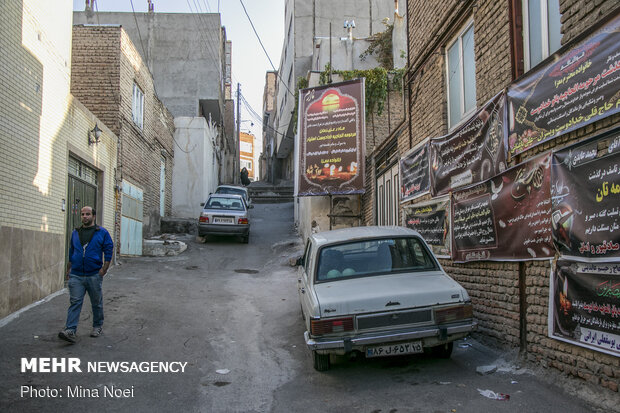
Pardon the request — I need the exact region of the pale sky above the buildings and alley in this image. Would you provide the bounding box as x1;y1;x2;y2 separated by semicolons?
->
73;0;285;153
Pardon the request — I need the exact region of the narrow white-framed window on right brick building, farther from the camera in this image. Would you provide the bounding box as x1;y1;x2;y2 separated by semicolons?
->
446;24;476;128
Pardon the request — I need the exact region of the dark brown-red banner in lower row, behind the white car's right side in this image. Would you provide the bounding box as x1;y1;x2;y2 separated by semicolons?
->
452;154;555;262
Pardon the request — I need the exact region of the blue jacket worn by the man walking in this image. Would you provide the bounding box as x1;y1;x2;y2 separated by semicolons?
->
69;226;114;275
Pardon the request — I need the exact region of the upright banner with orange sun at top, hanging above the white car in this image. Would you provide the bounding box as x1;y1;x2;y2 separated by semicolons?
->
297;78;366;196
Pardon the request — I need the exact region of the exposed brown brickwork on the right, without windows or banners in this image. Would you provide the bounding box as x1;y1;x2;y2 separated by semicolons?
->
398;0;620;392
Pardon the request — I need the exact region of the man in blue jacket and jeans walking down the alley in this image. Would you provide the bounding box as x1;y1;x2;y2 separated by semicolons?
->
58;206;114;343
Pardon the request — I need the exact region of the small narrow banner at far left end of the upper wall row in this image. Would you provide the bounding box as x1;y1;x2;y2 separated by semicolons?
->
399;142;431;203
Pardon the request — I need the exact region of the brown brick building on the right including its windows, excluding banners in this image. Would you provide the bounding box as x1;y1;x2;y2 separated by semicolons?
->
395;0;620;392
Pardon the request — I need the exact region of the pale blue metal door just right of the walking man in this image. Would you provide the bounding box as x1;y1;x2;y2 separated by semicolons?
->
120;180;144;255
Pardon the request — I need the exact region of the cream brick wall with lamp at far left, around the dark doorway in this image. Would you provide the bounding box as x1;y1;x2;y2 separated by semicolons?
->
0;0;117;317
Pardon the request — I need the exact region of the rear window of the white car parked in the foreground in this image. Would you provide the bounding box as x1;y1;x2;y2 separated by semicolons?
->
317;237;438;281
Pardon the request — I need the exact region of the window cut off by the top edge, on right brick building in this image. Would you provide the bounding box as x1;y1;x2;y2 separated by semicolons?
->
523;0;562;71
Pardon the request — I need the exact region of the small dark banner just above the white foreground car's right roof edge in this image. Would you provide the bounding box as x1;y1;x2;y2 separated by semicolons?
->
404;197;450;258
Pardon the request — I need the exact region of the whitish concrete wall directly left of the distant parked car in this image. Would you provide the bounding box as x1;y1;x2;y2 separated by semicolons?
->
172;117;218;218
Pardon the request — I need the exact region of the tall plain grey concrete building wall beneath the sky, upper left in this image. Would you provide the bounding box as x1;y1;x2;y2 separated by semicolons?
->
73;11;225;117
